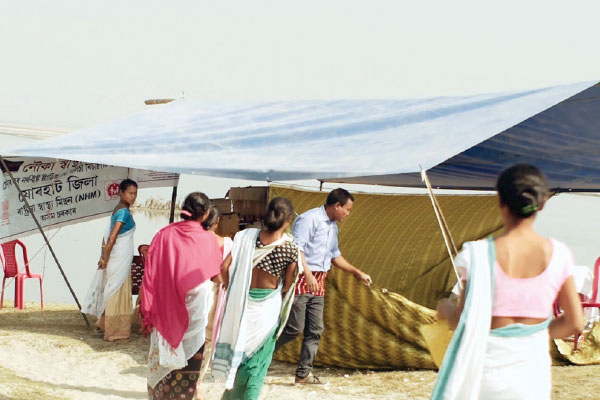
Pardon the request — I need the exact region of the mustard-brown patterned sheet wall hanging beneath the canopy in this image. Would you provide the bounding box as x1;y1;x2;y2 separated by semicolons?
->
269;186;501;369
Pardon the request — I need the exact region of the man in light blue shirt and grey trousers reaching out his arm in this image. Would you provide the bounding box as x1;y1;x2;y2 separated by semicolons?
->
277;188;371;384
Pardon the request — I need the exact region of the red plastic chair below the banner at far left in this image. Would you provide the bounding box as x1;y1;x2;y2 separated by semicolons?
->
0;240;44;310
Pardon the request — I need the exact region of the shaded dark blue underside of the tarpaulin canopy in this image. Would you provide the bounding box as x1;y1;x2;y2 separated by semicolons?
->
330;84;600;192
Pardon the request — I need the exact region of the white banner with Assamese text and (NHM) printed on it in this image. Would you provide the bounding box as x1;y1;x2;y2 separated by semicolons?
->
0;157;178;241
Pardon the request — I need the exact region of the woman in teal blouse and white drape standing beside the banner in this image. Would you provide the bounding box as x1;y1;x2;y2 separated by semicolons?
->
81;179;137;341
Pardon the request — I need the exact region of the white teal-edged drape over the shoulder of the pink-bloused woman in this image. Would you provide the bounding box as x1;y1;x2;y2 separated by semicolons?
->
431;239;496;400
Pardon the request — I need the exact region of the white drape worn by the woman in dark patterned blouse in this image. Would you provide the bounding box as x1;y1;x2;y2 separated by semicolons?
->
212;229;302;389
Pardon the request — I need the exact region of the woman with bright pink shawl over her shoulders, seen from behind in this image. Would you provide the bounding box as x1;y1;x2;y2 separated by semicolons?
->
141;192;222;399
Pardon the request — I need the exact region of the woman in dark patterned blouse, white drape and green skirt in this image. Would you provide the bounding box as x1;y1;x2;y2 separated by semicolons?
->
212;197;301;400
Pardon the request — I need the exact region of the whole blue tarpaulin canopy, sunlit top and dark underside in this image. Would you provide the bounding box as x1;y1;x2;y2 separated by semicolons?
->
5;82;600;191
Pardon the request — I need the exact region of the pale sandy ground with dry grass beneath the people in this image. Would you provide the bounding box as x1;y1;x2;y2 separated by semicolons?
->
0;302;600;400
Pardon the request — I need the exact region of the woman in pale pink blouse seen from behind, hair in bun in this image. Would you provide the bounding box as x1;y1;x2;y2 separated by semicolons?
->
432;164;583;400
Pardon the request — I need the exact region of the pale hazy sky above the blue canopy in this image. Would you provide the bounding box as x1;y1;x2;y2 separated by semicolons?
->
0;0;600;129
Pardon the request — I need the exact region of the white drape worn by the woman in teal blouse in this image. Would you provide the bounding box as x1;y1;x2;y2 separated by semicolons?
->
81;221;135;318
